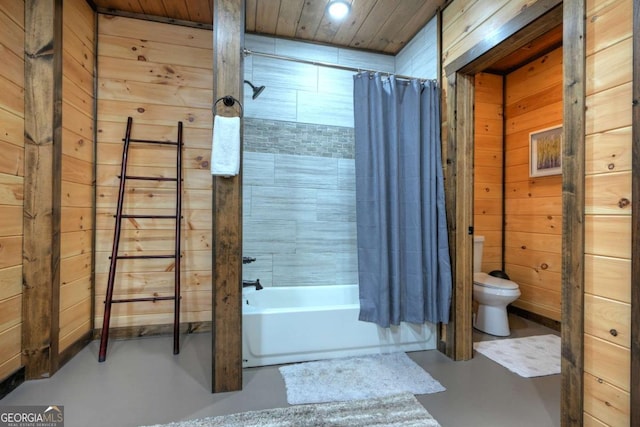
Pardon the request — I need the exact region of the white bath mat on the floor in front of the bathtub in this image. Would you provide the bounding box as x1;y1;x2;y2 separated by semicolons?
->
280;353;446;405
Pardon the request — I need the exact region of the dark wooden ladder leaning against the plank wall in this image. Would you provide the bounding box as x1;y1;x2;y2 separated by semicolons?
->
98;117;183;362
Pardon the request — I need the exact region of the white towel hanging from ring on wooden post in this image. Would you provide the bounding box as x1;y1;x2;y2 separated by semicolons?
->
211;116;240;177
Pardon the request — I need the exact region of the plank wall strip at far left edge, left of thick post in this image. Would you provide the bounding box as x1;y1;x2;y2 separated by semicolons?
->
0;0;24;382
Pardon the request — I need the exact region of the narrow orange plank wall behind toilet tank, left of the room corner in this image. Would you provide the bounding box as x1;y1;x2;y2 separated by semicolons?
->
473;73;504;273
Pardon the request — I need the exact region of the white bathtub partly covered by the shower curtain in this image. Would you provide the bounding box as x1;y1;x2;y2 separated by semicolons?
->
242;285;436;367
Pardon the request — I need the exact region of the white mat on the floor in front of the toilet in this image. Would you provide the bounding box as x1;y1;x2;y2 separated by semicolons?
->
473;335;560;378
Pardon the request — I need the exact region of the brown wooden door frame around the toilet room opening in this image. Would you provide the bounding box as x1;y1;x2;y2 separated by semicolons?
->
440;2;585;420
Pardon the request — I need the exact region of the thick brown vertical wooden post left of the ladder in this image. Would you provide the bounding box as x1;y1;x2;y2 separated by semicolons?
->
22;0;62;379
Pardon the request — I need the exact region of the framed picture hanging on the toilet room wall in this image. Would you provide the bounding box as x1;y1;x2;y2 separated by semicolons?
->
529;126;562;177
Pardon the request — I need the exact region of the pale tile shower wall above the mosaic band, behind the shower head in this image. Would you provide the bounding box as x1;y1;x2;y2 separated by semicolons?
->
244;34;396;127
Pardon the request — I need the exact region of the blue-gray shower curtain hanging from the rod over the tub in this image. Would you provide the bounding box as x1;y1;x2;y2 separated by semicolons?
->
354;73;451;327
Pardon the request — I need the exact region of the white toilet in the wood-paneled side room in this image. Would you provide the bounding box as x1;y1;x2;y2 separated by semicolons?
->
473;236;520;337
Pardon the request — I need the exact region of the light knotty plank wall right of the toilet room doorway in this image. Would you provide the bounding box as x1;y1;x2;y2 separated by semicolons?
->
584;0;638;426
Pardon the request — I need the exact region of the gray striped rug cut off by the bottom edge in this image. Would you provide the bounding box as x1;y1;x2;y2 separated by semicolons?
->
140;393;440;427
